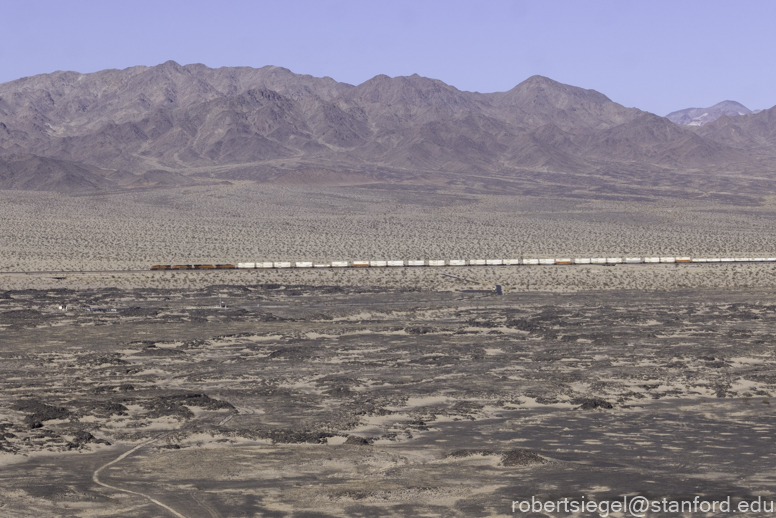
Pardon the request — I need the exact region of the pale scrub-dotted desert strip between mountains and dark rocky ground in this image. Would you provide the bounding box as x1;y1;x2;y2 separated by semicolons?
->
0;182;776;289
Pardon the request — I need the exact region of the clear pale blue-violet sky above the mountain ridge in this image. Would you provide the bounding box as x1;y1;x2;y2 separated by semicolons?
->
0;0;776;115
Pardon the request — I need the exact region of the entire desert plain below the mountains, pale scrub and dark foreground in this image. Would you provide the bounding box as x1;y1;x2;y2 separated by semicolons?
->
0;181;776;517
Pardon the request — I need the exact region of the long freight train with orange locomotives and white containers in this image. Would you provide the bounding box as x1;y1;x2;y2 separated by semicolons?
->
151;256;776;270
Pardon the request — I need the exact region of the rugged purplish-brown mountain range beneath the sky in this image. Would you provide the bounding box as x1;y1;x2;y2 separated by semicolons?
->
0;61;776;192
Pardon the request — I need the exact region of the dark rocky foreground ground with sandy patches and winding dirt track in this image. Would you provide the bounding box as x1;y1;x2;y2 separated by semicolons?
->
0;284;776;517
